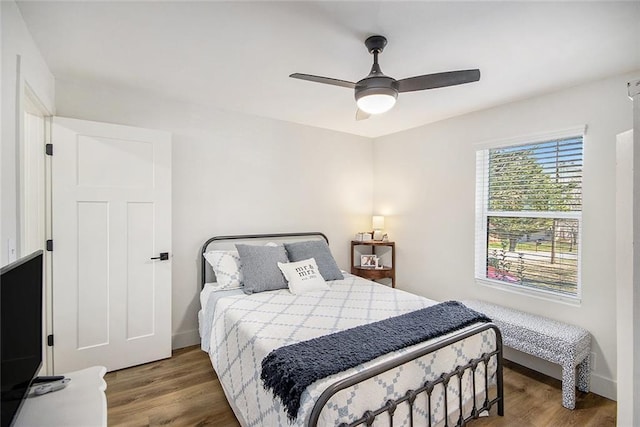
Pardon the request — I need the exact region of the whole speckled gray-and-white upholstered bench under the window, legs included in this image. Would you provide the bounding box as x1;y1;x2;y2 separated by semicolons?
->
462;300;591;409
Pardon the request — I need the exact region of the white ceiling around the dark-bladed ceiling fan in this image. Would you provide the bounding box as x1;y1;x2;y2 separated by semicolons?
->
13;1;640;137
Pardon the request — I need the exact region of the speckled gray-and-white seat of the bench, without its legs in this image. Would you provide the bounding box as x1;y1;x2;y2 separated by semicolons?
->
463;300;591;366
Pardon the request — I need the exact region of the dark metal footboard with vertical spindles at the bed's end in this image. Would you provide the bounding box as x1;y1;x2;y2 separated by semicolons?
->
307;323;504;427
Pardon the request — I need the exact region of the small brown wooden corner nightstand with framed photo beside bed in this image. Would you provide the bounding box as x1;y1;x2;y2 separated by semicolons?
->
351;240;396;288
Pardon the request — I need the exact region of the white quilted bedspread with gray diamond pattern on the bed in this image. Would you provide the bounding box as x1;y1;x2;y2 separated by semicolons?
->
201;274;495;426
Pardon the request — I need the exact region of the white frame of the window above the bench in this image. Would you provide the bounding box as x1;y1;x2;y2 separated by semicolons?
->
474;125;587;305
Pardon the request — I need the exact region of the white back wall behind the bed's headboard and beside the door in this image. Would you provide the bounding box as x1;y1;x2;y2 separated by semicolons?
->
56;81;373;347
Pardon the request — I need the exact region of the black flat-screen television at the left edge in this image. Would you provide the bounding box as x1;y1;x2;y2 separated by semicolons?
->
0;251;44;427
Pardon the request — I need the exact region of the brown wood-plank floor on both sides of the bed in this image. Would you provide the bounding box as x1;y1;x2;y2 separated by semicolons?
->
105;347;616;427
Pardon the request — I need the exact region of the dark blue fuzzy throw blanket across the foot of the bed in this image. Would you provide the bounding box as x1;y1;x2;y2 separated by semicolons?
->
261;301;491;420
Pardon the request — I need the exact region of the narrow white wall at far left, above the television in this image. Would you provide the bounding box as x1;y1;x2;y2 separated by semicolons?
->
0;1;55;265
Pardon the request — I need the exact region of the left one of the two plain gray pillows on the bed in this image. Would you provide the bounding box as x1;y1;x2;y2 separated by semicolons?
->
236;245;289;294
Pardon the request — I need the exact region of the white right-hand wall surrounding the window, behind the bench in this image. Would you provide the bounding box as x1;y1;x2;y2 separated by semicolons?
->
374;73;638;397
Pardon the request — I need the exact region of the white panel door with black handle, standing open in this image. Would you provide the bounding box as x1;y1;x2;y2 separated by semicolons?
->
52;117;171;374
